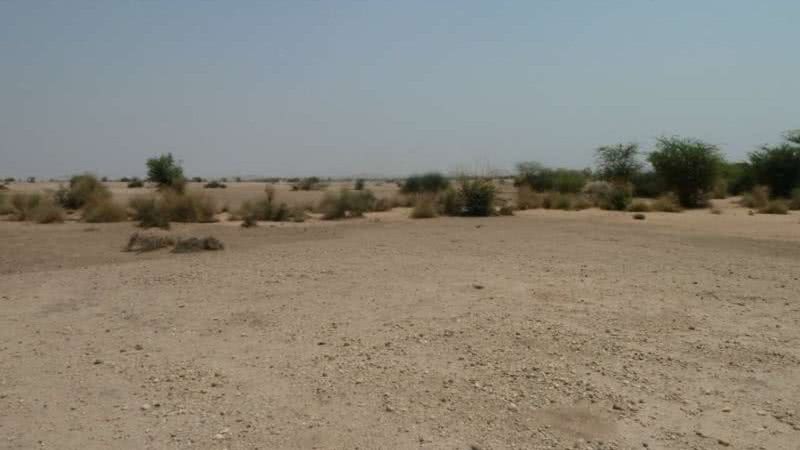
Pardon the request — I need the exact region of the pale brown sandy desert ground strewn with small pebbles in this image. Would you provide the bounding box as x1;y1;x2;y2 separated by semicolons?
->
0;183;800;450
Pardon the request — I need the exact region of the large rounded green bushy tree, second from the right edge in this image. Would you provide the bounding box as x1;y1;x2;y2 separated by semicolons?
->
649;137;723;208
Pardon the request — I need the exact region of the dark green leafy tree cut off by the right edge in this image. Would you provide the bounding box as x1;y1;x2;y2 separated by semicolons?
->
750;130;800;197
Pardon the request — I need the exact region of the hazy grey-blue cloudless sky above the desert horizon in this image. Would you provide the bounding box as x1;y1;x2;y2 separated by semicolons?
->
0;0;800;178
